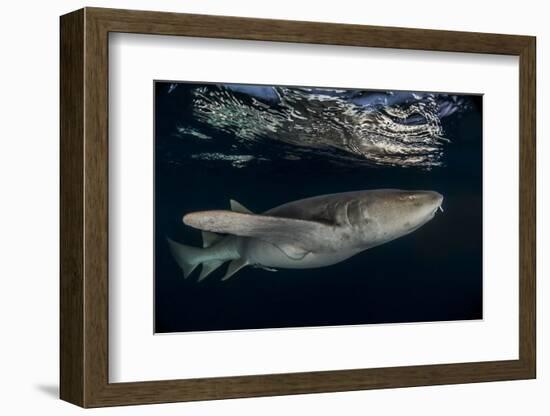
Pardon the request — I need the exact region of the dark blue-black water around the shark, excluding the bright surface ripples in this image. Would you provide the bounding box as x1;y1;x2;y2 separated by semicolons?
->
154;82;482;332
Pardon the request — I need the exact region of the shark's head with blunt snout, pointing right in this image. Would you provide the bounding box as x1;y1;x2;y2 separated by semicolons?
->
360;189;443;244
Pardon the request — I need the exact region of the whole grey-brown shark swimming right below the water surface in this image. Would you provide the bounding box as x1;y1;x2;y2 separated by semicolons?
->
168;189;443;281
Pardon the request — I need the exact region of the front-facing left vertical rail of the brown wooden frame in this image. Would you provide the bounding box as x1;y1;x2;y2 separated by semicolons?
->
84;11;109;406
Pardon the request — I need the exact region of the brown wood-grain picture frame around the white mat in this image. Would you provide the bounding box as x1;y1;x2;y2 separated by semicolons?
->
60;8;536;407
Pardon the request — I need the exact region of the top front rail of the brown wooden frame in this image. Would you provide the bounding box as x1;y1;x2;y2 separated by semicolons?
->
86;8;529;55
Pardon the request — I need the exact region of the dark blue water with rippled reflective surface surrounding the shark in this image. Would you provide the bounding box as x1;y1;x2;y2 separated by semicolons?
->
154;82;482;332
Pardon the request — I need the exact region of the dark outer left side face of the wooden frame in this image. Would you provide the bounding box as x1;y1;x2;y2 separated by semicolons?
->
59;10;86;406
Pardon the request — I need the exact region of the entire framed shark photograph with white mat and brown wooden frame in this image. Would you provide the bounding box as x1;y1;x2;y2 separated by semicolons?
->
60;8;536;407
